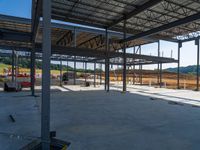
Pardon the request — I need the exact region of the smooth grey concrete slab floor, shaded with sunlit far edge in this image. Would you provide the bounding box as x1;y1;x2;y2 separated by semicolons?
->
0;86;200;150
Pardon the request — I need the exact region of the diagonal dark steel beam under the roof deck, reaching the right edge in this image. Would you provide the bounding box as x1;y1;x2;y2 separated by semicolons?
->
119;12;200;43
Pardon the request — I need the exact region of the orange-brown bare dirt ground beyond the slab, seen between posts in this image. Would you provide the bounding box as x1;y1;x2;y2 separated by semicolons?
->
0;70;196;90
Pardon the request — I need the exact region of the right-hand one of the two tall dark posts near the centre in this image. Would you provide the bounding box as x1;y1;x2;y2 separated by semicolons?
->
123;19;126;92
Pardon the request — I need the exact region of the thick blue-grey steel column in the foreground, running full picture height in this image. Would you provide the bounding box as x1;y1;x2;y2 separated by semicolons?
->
41;0;51;150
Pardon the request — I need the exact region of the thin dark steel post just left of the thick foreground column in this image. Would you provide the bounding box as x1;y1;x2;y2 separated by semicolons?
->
30;42;35;96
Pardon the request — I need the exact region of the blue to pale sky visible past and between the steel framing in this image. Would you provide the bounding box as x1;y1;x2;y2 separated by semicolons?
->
0;0;197;69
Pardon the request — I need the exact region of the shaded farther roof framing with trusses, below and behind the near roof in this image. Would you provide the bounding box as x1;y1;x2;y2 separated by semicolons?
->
0;15;154;51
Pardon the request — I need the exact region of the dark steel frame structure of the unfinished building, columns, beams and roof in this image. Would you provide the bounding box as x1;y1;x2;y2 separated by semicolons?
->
0;0;200;149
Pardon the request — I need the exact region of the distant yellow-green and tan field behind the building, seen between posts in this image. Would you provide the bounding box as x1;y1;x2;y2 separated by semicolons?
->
0;63;199;90
